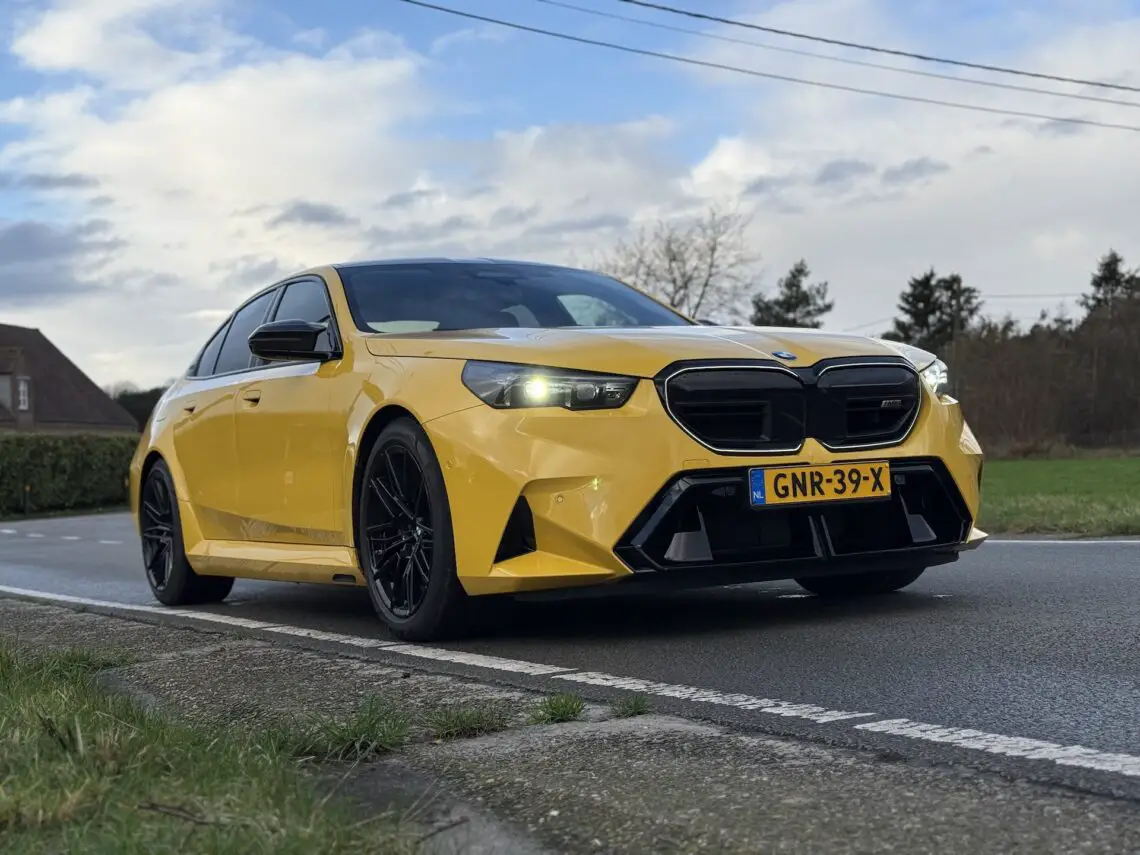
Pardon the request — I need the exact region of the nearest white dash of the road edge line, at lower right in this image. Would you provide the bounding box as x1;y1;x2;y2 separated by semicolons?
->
855;718;1140;777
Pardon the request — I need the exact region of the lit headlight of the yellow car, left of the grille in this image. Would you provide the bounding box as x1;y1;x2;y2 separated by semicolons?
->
463;361;637;409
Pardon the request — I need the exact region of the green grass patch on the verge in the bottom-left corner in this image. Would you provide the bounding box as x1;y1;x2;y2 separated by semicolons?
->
0;645;415;855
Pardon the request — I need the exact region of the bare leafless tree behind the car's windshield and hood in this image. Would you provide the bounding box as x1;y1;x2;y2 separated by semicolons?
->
593;205;759;323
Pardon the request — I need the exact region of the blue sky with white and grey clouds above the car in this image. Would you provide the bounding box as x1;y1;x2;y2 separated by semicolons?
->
0;0;1140;385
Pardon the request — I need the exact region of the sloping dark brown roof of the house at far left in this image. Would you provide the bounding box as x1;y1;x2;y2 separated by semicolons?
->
0;324;138;430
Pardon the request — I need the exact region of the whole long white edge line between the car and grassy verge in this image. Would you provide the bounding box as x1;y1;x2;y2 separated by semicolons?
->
0;585;1140;777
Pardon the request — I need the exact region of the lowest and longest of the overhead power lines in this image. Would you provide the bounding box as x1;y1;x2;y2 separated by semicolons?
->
399;0;1140;133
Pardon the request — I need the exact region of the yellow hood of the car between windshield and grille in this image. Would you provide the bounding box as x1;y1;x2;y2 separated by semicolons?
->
366;326;899;377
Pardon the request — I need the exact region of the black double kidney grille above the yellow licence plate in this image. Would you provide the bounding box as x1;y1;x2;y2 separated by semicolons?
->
658;359;922;454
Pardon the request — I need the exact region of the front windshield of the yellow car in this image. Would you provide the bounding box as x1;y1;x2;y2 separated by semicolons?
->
340;261;692;333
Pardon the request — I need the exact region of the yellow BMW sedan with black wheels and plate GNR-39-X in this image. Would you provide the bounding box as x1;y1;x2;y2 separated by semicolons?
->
130;259;985;641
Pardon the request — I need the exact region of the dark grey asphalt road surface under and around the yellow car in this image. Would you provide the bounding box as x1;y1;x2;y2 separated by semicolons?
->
0;514;1140;792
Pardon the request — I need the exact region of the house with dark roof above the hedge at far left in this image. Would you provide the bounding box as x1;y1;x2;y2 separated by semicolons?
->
0;324;138;433
